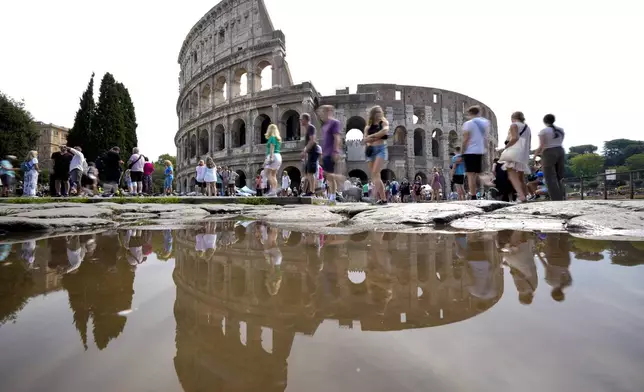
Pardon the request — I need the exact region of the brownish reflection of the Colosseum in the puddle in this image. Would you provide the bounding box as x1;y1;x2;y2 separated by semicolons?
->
174;224;503;391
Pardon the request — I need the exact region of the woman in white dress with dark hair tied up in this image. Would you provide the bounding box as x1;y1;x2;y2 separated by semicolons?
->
499;112;532;203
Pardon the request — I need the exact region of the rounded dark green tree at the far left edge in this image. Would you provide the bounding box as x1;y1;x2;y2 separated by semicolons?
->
0;91;38;160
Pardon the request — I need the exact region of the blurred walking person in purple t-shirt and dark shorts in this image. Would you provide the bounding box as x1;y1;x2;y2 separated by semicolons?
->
319;105;342;204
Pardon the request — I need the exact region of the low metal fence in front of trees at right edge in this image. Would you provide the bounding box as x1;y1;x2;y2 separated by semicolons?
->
563;170;644;200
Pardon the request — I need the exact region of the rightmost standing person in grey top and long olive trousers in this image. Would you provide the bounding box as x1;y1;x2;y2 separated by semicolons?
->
535;114;566;201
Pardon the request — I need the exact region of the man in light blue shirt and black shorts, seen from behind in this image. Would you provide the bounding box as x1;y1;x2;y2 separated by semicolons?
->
463;105;490;200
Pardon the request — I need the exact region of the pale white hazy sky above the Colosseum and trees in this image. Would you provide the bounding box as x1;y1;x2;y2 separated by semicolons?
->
0;0;644;157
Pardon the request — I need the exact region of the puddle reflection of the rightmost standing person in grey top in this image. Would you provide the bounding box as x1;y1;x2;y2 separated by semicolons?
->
538;233;572;302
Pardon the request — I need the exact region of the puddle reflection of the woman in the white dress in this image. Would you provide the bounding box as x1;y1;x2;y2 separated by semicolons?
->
498;231;539;305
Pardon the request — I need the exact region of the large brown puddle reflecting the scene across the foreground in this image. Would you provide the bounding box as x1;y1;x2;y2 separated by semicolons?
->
0;220;644;392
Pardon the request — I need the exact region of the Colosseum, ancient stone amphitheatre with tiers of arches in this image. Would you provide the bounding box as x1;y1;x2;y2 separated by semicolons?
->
175;0;498;192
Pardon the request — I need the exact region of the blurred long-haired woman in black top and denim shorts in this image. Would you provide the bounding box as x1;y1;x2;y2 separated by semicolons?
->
364;106;389;204
